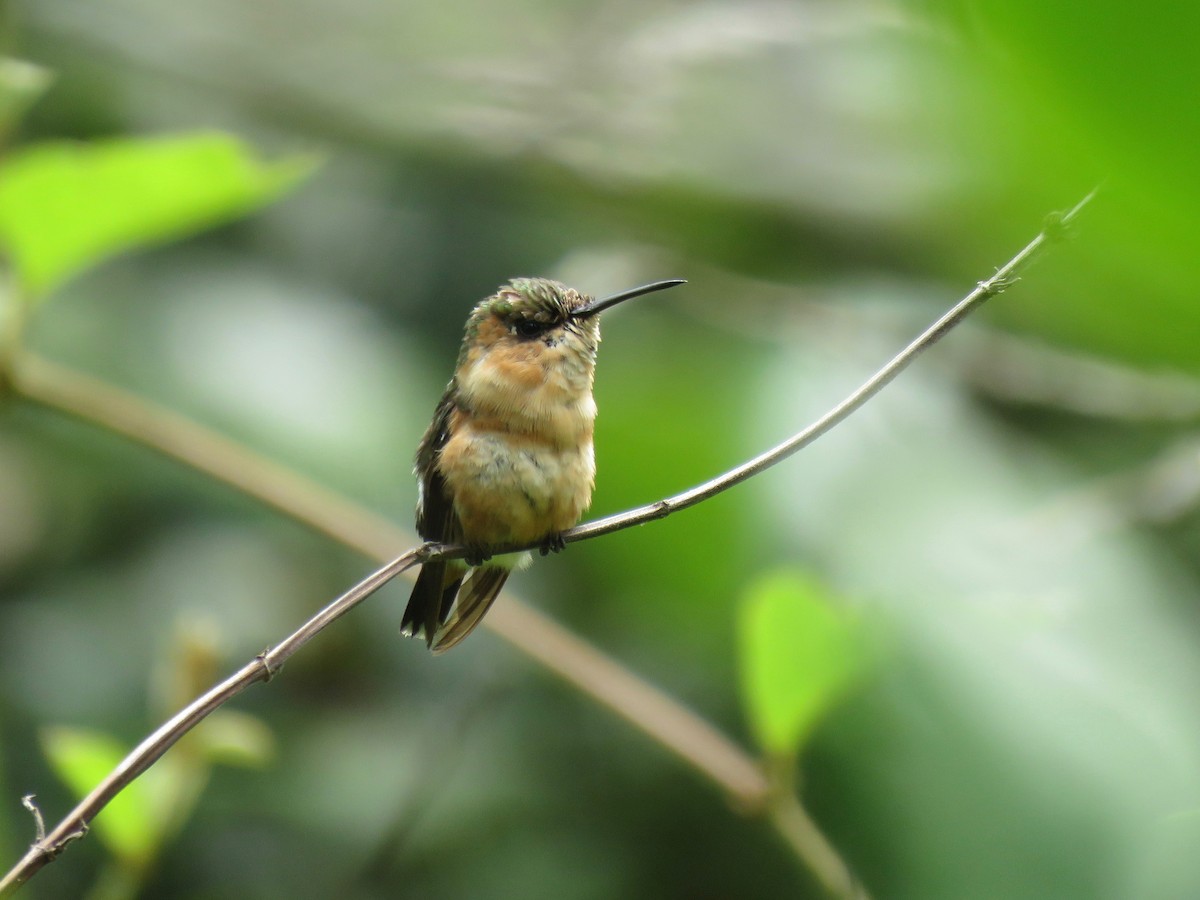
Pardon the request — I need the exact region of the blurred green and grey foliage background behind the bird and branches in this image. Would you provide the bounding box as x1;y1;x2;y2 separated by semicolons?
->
0;0;1200;900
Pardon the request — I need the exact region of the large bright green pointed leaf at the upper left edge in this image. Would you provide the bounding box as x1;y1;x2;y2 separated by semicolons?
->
0;133;314;298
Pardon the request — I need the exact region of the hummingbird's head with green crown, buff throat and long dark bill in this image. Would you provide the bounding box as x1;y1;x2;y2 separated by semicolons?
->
455;278;683;441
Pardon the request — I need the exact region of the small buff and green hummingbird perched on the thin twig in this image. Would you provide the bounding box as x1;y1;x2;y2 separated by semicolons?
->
401;278;684;653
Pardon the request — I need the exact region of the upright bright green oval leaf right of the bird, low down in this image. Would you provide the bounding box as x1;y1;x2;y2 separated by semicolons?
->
739;571;866;756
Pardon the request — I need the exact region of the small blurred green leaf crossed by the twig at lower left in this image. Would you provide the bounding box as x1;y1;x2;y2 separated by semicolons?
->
41;727;160;864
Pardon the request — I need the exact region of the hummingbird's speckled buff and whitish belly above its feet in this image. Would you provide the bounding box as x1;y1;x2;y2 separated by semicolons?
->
438;427;595;545
